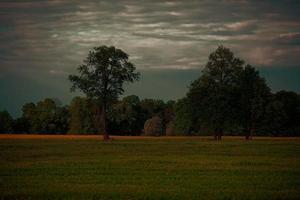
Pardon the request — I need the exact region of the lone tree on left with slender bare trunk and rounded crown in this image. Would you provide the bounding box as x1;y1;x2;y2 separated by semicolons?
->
69;46;140;140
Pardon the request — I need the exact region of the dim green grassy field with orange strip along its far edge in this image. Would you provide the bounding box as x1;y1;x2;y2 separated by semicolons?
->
0;136;300;199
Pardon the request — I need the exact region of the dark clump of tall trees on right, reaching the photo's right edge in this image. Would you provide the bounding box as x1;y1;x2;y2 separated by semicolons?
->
183;46;300;139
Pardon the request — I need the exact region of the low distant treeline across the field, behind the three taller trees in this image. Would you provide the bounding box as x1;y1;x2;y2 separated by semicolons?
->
0;91;300;136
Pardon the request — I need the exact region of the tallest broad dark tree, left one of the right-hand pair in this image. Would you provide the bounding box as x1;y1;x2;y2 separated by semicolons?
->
187;46;244;140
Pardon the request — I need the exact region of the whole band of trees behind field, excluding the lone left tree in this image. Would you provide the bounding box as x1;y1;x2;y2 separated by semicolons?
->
0;46;300;139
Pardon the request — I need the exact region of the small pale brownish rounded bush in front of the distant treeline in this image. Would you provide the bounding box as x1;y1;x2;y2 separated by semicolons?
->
144;116;163;136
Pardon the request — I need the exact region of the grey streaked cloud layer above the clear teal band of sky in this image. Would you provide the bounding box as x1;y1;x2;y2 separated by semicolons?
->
0;0;299;71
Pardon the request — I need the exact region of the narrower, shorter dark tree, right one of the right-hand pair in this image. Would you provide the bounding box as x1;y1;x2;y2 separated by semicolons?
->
236;65;271;140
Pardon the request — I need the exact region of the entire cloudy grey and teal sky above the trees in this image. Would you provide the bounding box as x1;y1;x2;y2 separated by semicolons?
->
0;0;300;117
